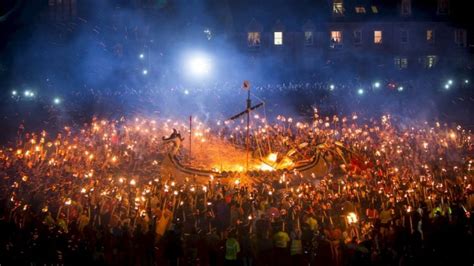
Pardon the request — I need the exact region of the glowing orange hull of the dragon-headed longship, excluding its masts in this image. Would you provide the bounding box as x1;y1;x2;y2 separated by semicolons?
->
163;128;350;178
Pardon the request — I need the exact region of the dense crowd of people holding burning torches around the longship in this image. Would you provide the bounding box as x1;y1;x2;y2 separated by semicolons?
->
0;110;474;265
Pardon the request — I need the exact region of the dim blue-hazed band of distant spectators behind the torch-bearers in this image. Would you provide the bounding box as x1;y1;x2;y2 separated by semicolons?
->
1;78;474;139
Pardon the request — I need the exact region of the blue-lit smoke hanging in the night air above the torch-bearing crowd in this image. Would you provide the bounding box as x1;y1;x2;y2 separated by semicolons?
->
1;0;472;137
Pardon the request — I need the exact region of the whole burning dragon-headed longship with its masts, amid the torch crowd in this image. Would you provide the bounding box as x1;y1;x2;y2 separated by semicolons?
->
163;81;354;180
